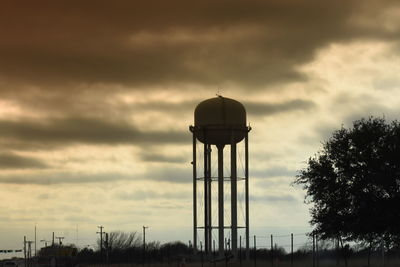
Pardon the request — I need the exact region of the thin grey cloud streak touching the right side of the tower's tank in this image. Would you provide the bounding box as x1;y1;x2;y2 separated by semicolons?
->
244;99;316;116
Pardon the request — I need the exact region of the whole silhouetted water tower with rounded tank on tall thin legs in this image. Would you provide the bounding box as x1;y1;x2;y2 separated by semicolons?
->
189;96;251;258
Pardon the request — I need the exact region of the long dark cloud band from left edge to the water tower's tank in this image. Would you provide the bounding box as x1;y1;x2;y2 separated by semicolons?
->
0;118;190;148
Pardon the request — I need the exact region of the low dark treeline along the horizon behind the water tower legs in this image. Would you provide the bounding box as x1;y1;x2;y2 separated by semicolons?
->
77;232;400;265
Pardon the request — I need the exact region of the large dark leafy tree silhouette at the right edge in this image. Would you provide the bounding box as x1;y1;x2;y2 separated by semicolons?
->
295;117;400;251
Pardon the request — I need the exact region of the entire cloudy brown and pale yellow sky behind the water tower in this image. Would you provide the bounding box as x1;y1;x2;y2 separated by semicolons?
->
0;0;400;255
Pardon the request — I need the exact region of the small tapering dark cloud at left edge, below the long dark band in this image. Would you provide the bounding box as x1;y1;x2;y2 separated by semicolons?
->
0;153;49;170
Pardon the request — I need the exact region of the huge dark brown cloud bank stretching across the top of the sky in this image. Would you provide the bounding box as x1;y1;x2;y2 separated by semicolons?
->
0;0;399;91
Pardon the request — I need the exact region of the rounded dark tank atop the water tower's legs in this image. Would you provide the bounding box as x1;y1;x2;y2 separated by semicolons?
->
194;96;247;145
